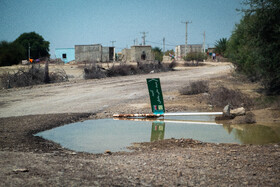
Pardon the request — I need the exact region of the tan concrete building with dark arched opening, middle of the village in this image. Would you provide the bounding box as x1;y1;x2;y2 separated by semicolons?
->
121;45;155;62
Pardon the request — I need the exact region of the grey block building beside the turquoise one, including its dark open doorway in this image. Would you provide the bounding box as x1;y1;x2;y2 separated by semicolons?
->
75;44;114;62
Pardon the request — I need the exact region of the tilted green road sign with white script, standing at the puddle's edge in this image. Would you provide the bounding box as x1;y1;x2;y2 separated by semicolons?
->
147;78;165;114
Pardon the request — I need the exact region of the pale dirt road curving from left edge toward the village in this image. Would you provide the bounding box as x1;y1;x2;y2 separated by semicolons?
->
0;63;231;117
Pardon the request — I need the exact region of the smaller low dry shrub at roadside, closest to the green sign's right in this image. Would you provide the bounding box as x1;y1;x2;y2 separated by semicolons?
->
179;81;209;95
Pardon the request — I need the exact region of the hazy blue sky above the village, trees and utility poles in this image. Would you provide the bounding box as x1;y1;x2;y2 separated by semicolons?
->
0;0;242;57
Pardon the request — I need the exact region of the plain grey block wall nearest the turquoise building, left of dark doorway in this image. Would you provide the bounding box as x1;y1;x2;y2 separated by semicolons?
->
75;44;102;62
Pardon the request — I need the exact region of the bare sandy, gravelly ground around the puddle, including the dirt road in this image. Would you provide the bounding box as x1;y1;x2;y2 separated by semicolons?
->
0;63;280;186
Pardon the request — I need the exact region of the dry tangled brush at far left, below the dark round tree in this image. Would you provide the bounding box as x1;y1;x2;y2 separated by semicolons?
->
0;64;68;88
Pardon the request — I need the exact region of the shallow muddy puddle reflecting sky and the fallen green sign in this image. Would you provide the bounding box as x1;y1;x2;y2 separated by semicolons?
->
35;116;280;153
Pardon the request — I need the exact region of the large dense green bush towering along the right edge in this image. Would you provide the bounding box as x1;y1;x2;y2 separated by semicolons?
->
226;0;280;95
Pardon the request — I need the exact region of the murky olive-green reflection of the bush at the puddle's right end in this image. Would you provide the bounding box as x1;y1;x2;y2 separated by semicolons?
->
223;124;280;145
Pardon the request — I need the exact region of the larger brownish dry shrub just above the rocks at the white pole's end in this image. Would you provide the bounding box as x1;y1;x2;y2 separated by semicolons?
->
210;86;253;109
